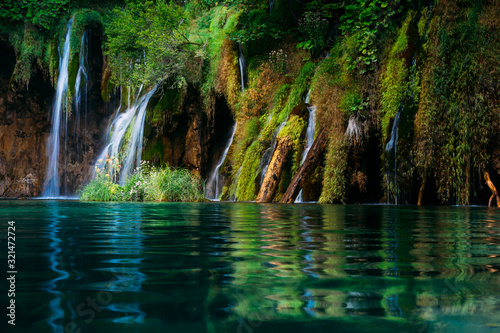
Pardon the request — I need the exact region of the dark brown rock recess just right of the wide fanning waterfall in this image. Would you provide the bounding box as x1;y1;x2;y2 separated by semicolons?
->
143;87;233;178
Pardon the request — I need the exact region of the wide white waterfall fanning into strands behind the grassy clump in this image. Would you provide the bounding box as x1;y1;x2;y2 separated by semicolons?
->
96;85;158;185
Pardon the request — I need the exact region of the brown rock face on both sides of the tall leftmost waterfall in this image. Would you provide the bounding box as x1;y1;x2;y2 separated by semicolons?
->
0;30;113;198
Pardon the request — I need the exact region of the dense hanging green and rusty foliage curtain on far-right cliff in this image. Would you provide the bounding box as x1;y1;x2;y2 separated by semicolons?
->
416;2;500;205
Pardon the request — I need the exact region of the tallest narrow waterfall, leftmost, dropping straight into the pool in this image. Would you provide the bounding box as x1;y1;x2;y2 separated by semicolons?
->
42;19;73;198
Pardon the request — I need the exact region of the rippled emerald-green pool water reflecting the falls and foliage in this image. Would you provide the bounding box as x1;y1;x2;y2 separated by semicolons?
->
0;200;500;333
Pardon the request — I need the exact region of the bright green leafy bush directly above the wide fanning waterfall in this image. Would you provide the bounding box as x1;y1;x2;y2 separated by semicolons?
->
106;1;191;87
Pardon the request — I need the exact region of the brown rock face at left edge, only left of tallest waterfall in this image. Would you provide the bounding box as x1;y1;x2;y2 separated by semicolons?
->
0;41;53;197
